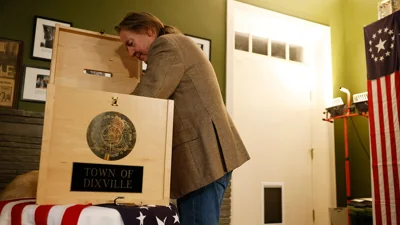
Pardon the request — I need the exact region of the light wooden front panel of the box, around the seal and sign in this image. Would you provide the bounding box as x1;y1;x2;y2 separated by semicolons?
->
37;85;173;205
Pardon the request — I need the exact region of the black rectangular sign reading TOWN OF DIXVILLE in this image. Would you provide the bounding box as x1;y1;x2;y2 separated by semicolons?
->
71;162;143;193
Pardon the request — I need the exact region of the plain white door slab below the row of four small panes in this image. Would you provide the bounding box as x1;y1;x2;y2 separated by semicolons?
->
233;50;313;225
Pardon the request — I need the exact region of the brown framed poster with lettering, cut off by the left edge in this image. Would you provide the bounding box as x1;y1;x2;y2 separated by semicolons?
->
0;38;24;108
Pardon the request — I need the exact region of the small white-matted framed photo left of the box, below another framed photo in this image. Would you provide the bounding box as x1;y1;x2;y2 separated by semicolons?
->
21;66;50;103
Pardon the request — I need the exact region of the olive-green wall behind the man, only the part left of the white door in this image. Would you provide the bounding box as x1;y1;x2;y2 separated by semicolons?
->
0;0;226;111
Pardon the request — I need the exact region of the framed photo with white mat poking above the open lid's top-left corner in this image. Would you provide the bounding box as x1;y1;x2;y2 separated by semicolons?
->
32;16;72;60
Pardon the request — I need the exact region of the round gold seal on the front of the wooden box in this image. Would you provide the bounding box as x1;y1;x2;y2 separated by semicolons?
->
86;111;136;161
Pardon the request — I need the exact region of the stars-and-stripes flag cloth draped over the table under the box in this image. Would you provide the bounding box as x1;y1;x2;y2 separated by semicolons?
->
0;198;180;225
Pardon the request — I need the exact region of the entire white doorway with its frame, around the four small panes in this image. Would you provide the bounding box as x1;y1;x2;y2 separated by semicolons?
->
227;1;336;225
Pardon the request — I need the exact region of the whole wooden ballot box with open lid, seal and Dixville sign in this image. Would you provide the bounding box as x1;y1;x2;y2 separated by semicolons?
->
37;25;173;205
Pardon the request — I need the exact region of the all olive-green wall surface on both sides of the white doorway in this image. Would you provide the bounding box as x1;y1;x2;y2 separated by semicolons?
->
0;0;376;205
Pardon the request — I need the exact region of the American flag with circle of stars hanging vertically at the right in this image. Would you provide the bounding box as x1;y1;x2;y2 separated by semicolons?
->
364;11;400;225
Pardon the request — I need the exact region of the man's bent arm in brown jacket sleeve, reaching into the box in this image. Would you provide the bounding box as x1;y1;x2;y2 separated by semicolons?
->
132;37;184;99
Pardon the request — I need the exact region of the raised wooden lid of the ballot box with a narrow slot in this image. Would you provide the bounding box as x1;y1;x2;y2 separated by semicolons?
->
51;25;142;94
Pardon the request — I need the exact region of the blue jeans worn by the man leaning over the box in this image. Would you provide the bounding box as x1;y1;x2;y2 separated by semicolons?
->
177;172;232;225
